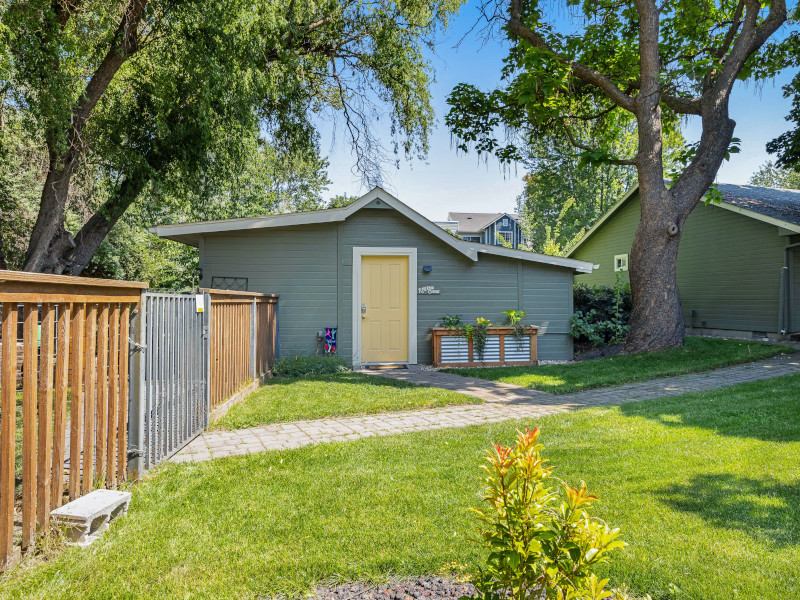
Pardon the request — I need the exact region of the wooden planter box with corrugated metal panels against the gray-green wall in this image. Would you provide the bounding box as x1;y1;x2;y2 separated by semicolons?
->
431;326;539;367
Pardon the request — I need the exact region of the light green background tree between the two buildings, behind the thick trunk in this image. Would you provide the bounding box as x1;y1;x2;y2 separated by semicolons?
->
517;114;685;254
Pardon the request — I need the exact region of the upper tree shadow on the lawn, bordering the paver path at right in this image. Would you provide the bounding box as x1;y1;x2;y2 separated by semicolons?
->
619;374;800;442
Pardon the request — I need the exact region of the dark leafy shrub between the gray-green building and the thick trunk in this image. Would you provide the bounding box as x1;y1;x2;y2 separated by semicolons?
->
570;277;631;346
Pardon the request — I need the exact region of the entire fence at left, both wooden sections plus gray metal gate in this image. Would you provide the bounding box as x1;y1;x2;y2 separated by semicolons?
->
0;270;278;571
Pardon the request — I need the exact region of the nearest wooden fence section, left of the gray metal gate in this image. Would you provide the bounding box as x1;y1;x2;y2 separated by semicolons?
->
0;271;147;570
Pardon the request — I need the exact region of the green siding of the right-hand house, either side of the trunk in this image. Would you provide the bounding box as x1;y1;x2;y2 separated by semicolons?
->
572;196;786;333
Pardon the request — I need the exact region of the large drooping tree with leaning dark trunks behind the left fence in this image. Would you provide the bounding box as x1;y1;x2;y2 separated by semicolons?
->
6;0;462;274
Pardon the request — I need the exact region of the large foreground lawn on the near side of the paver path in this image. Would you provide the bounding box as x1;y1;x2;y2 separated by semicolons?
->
0;376;800;600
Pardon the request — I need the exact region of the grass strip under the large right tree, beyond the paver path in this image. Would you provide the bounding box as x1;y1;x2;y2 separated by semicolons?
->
444;338;793;394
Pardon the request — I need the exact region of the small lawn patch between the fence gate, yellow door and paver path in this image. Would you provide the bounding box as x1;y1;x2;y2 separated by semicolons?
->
209;373;481;429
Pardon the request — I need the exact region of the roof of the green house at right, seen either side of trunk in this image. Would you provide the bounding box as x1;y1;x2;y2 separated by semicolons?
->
567;183;800;256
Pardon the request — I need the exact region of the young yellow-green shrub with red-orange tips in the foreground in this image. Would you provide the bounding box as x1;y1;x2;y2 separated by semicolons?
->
472;428;624;600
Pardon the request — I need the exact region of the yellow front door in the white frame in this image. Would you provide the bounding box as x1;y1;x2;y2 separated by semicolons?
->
361;256;408;363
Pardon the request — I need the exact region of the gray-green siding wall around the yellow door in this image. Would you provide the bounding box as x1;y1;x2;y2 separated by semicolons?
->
200;208;573;363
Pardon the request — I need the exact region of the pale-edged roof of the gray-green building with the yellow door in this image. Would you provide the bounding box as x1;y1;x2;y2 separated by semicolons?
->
150;187;593;273
